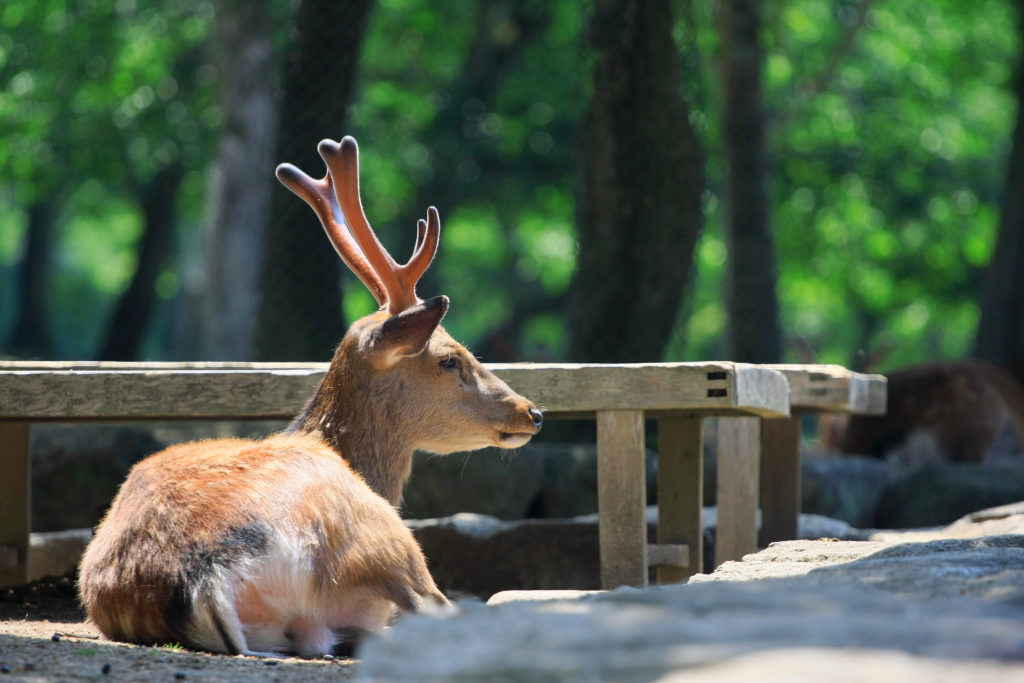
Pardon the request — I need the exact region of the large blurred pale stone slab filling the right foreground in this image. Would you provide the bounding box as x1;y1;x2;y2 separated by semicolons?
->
356;520;1024;682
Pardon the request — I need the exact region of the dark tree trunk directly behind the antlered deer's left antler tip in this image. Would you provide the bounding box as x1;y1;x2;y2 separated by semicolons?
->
256;0;371;360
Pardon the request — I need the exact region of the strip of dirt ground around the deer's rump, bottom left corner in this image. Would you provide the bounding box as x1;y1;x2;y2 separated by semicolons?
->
0;577;354;683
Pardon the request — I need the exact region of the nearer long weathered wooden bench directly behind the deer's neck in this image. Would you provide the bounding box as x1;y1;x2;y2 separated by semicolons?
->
0;361;790;587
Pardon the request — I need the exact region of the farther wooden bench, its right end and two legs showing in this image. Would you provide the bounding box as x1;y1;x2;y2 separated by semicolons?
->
715;365;887;565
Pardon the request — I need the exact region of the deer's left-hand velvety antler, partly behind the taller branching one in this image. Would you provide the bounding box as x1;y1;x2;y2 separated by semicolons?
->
274;164;388;306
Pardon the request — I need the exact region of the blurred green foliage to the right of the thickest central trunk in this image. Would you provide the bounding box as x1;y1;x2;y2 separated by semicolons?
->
675;0;1019;365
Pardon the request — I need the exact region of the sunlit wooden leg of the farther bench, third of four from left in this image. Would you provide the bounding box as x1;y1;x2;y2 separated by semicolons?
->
715;418;761;566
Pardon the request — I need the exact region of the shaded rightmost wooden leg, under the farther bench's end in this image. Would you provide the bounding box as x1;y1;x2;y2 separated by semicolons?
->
759;416;800;547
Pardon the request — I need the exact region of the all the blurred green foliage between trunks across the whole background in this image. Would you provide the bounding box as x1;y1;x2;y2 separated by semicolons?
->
0;0;1020;364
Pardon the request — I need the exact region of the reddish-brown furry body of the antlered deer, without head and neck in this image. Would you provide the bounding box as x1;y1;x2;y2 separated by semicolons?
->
80;435;432;651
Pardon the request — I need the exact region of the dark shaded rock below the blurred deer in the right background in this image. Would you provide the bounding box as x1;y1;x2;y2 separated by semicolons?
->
874;463;1024;528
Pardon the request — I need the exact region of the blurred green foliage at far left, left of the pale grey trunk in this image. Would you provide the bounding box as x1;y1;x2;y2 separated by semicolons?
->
0;0;221;357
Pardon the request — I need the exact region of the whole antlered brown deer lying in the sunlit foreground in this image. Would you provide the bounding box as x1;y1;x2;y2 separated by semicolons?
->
79;137;542;656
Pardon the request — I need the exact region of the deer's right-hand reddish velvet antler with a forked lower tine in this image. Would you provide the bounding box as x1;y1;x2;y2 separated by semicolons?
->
317;135;440;314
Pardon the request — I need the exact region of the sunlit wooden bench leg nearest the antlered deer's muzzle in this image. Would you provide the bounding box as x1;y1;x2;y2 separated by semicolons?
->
597;411;647;589
